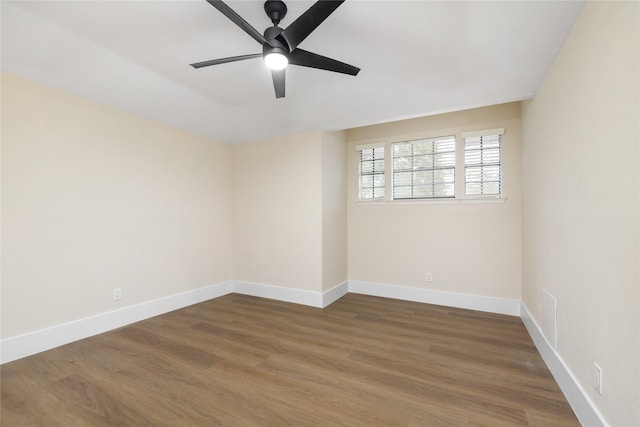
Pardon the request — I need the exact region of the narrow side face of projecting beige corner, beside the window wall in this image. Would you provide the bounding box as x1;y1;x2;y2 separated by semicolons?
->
321;132;347;291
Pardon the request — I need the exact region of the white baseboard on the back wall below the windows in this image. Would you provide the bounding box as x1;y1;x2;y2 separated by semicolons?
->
349;280;520;316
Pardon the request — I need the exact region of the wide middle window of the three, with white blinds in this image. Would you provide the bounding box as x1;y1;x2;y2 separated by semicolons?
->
392;136;456;199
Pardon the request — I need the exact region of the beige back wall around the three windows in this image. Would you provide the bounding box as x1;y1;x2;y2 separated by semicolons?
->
347;103;521;299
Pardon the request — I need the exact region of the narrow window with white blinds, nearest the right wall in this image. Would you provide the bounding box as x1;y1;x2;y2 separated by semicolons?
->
464;135;502;197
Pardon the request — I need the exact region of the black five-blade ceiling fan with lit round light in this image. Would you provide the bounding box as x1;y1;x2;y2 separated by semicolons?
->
191;0;360;98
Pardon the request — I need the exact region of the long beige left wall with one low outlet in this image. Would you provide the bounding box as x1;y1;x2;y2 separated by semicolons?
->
2;73;232;338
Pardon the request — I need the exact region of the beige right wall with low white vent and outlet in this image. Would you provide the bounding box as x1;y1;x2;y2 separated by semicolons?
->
522;2;640;426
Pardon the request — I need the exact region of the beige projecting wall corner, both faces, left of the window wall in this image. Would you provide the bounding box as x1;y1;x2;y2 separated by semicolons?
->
232;131;347;292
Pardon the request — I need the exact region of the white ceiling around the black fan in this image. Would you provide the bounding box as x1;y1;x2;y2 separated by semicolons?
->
1;0;584;143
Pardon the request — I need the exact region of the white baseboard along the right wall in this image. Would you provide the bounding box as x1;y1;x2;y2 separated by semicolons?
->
520;303;608;427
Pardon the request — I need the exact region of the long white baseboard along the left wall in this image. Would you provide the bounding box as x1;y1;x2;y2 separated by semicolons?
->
0;281;233;363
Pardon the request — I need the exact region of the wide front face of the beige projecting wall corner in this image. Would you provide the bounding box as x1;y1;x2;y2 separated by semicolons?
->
231;132;322;291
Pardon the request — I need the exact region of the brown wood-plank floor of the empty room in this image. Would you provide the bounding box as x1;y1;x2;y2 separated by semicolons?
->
0;294;579;427
